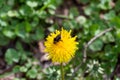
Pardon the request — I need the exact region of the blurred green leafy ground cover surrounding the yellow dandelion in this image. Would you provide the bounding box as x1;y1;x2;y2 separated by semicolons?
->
0;0;120;80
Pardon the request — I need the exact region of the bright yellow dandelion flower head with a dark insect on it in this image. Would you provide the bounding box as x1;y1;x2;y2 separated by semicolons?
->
45;28;78;63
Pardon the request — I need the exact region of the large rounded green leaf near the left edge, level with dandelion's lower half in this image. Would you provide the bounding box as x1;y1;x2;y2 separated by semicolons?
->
5;48;20;64
